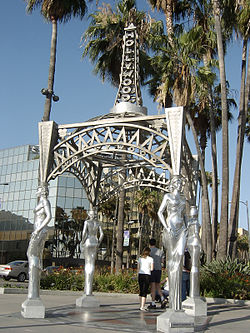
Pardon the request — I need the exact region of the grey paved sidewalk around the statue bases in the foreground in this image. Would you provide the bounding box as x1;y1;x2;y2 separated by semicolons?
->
0;290;250;333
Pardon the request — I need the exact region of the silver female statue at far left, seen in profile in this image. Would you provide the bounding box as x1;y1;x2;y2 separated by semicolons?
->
27;185;52;299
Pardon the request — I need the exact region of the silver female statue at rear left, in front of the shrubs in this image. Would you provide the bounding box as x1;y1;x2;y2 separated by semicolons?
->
82;210;104;296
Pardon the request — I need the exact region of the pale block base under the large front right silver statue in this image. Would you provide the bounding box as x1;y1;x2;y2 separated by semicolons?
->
157;309;194;333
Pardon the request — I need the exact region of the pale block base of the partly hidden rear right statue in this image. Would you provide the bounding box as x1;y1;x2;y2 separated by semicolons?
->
182;297;207;317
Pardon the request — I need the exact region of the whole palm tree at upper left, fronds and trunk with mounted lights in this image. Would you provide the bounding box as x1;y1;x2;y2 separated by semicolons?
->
25;0;92;121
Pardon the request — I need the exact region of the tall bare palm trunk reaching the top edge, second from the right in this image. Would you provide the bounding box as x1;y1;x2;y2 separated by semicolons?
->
213;0;229;259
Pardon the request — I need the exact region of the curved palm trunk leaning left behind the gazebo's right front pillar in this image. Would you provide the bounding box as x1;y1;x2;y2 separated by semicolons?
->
186;112;212;263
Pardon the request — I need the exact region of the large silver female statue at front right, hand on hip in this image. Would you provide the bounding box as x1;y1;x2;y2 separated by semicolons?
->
158;176;187;311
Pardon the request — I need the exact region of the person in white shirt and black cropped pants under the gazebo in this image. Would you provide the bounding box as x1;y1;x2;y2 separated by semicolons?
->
138;247;154;311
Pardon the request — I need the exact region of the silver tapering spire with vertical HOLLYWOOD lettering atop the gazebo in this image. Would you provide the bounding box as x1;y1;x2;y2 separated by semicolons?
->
110;23;147;115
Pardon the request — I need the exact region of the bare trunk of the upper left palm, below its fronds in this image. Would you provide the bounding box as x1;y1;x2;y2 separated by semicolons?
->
43;19;57;121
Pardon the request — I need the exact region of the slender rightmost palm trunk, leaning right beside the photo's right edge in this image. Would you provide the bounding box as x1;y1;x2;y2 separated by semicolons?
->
228;39;250;259
